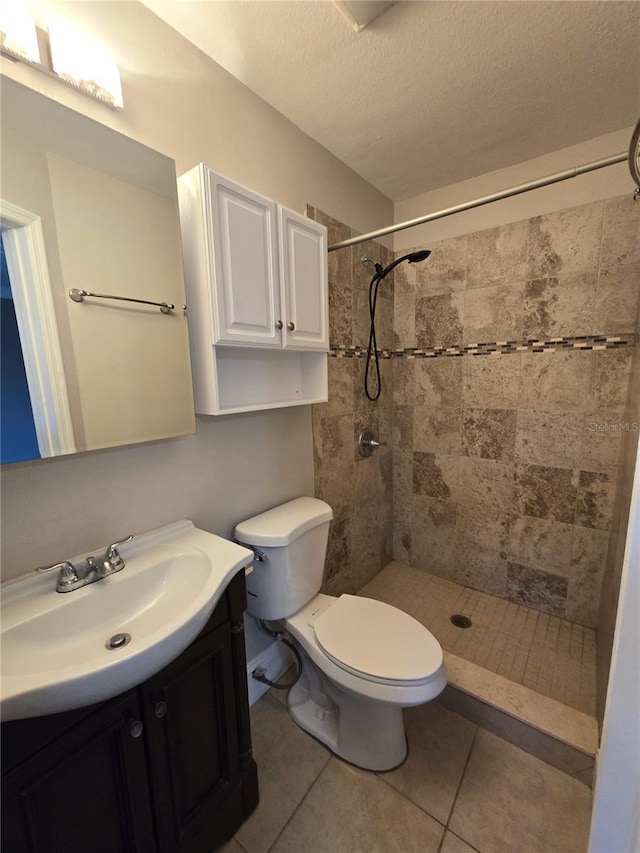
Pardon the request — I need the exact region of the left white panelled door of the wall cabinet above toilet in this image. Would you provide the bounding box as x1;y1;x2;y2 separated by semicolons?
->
203;167;282;347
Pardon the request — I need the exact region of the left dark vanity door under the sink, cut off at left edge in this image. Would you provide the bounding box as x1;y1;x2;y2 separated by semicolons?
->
2;693;156;853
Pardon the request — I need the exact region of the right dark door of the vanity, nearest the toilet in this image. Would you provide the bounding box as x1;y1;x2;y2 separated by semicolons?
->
141;623;243;853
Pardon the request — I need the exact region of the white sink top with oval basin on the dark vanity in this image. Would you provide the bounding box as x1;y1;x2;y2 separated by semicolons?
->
0;521;253;720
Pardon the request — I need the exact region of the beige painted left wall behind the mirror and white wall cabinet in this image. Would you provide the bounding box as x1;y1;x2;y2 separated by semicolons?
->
2;2;393;578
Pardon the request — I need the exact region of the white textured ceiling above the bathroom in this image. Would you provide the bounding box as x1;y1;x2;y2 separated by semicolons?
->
145;0;640;201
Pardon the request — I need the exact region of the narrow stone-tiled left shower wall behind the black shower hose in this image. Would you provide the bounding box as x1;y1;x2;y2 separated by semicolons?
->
307;208;393;595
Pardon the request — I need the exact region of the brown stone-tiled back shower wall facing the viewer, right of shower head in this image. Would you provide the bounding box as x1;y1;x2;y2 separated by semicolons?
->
392;195;640;627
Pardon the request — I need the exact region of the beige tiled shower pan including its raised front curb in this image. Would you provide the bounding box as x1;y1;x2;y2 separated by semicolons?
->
360;562;598;784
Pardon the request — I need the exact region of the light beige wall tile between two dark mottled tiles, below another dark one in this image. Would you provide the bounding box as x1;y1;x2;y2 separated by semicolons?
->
458;456;515;518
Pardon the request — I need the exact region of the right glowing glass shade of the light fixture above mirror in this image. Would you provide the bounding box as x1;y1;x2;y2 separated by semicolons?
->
49;21;123;107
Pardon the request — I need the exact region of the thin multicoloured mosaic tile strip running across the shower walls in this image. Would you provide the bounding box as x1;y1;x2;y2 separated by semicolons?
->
329;335;636;358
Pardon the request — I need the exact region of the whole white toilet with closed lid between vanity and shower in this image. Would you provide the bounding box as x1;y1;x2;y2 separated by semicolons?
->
235;498;447;770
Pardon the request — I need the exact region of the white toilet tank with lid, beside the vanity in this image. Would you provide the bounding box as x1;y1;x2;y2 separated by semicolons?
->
235;498;333;619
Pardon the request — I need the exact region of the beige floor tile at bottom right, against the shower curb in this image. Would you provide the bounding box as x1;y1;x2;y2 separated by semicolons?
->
449;729;591;853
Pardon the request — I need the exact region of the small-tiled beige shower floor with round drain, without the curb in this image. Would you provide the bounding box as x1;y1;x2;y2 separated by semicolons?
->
360;562;596;716
